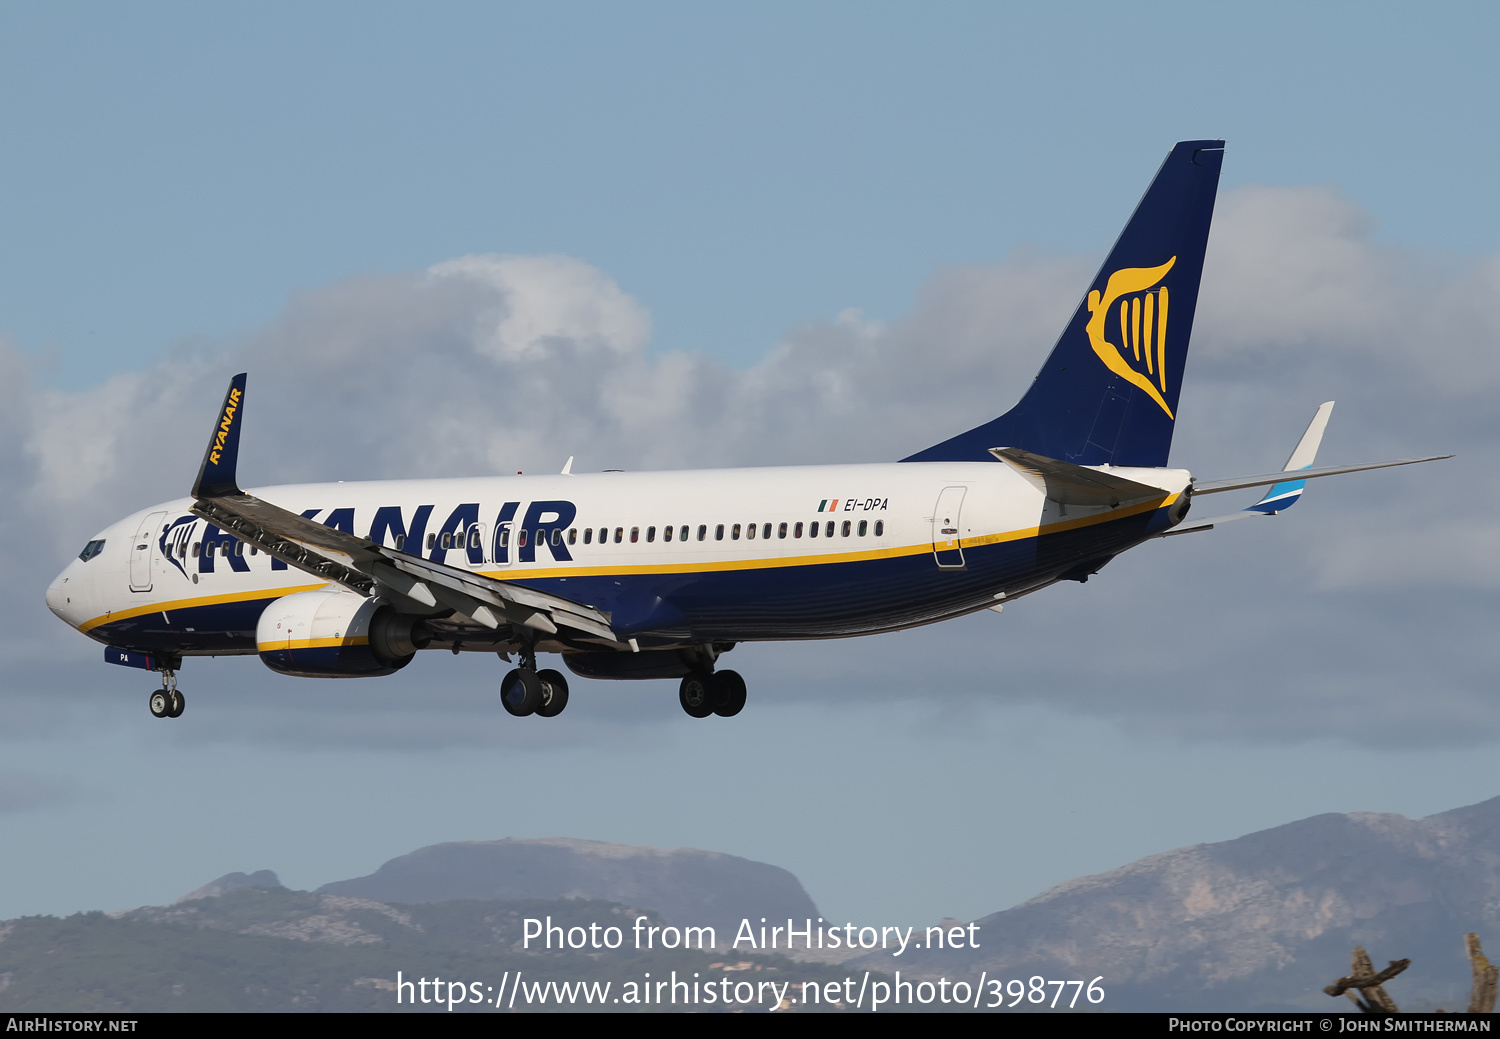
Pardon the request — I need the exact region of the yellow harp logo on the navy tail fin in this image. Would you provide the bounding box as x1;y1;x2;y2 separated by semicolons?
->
1085;256;1178;418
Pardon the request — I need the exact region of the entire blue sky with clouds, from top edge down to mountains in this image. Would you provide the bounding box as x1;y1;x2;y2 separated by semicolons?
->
0;3;1500;922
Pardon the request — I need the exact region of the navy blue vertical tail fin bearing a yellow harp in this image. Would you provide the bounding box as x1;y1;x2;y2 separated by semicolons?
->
902;141;1224;468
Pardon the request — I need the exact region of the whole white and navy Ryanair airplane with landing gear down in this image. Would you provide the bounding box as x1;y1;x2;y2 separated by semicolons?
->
47;141;1451;718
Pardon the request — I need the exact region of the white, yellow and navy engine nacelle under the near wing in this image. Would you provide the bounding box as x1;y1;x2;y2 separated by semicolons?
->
255;589;432;678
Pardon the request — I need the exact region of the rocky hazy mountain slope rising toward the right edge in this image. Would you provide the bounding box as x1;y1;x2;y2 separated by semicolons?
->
860;798;1500;1009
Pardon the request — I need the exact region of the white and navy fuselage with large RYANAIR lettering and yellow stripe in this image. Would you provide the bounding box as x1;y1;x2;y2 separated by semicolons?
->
47;462;1190;665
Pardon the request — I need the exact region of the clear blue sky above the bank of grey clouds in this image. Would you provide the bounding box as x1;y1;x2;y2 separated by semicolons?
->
11;3;1497;385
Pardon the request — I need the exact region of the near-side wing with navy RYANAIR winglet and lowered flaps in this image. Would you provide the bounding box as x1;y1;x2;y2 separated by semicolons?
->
192;373;627;649
